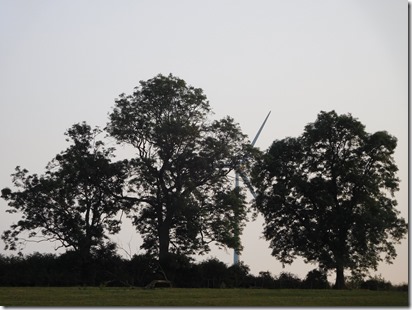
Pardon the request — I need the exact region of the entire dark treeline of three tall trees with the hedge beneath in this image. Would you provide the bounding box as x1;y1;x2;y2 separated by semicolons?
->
0;74;408;289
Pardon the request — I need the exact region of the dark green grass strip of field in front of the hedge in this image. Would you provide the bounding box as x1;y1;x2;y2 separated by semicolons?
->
0;287;409;307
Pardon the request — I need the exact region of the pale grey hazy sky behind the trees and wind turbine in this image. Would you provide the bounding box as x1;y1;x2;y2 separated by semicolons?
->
0;0;409;284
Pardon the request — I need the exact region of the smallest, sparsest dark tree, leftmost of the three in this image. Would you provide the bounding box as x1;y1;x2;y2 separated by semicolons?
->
1;123;127;284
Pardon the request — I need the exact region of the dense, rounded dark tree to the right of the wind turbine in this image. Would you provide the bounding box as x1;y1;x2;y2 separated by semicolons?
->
253;111;407;288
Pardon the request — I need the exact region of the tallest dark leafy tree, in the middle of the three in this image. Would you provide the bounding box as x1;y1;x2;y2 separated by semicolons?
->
106;75;251;263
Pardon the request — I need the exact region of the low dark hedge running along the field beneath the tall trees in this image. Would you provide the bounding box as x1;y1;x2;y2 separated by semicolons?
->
0;249;408;291
